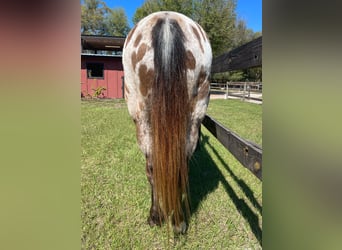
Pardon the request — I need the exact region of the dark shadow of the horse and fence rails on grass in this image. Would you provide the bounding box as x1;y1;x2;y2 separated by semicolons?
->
189;134;262;245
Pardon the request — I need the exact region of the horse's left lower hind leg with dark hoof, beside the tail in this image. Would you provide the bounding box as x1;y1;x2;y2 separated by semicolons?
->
146;157;164;227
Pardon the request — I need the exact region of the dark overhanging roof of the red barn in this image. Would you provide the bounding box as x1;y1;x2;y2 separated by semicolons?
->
81;35;126;50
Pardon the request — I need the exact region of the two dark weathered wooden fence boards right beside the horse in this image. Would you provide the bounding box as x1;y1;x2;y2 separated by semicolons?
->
202;37;262;180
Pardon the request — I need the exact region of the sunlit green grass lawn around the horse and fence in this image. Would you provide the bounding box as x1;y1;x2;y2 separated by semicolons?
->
81;100;262;249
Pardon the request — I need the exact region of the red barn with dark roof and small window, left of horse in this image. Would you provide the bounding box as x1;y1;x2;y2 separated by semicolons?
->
81;35;125;98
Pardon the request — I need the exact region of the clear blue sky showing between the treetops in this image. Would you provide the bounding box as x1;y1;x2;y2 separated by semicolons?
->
104;0;262;32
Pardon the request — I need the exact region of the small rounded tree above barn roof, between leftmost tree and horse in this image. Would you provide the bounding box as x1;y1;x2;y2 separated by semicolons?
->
105;8;130;36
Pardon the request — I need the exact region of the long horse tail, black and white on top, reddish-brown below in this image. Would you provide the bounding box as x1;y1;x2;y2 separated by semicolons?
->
151;17;190;230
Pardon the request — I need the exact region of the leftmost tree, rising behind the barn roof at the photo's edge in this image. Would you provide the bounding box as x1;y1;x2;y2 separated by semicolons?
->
81;0;109;35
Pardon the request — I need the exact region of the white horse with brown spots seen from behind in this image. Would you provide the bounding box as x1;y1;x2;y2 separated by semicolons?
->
122;11;212;233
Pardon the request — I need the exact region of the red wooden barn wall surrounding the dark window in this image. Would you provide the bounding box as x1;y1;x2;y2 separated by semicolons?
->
81;55;124;98
